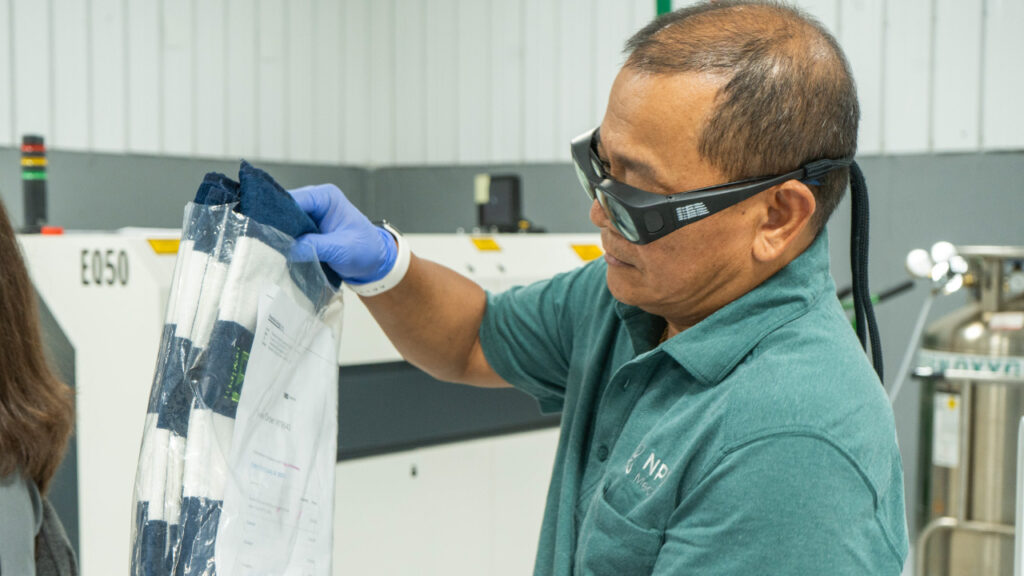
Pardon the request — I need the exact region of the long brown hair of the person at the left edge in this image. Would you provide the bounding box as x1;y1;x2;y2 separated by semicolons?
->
0;195;74;492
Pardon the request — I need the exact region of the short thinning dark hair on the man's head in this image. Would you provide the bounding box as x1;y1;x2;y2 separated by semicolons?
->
625;0;860;230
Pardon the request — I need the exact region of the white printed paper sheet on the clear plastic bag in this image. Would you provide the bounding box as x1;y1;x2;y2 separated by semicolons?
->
216;286;338;576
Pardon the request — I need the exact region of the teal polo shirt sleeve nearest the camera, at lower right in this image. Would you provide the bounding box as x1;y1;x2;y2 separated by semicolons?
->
653;435;906;576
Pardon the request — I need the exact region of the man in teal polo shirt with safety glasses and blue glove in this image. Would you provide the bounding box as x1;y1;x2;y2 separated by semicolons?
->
294;2;907;575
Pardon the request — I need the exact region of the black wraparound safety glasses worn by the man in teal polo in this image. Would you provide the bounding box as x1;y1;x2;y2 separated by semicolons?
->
571;127;852;244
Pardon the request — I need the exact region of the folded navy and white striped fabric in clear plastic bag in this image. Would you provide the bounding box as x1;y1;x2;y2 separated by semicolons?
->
132;162;339;576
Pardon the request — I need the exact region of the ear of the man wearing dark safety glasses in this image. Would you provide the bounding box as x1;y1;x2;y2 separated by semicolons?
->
754;180;817;262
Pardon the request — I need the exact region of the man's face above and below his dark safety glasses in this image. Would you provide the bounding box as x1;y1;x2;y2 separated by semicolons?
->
590;69;756;329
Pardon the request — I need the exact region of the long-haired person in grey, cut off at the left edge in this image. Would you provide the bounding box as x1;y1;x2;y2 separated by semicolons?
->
0;194;78;576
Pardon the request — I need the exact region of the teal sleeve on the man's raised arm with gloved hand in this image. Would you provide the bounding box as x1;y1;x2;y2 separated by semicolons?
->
480;260;594;413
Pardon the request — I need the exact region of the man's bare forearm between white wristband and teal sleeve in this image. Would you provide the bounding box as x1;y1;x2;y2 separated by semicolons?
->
362;254;508;387
